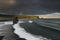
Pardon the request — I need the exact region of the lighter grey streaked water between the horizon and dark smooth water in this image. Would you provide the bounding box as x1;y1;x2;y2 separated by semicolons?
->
34;19;60;30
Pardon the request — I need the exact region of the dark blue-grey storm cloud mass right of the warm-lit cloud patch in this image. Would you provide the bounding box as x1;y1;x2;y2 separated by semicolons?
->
0;0;60;14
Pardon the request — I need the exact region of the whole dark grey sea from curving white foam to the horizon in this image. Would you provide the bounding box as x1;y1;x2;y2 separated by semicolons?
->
20;19;60;40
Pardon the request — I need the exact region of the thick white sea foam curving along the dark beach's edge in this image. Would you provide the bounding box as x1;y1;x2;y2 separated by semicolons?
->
14;22;48;40
